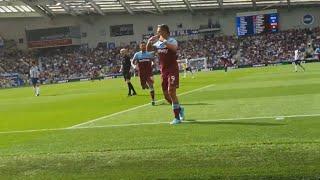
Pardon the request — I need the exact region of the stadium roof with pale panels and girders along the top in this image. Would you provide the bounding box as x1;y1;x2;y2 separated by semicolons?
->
0;0;320;17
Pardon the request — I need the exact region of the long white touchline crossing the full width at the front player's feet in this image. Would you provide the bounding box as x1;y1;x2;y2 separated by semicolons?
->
0;114;320;134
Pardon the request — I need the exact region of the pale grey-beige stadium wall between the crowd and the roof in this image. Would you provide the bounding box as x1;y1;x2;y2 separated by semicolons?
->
0;6;320;49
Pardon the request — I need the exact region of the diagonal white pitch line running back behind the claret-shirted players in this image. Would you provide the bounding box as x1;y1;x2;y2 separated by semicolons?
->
69;84;214;129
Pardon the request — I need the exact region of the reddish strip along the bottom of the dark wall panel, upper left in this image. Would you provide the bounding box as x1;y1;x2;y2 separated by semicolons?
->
28;39;72;48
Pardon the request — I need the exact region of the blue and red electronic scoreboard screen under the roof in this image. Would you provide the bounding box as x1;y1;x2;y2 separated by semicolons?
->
236;11;279;36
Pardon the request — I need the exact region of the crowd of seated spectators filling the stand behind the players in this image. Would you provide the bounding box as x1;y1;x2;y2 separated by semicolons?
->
0;27;320;87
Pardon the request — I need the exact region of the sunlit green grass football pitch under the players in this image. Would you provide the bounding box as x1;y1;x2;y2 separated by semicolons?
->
0;63;320;179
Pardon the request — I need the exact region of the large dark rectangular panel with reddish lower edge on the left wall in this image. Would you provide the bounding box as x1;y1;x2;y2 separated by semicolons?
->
26;27;80;48
